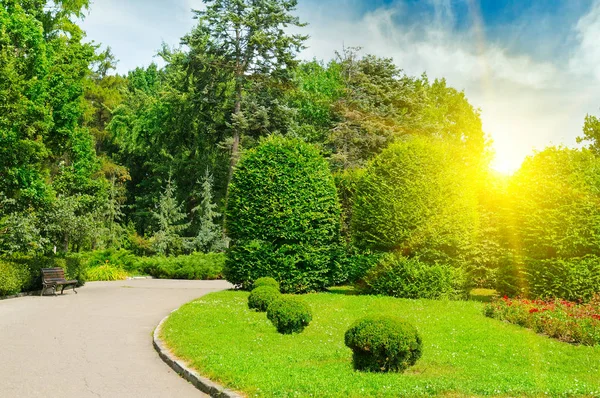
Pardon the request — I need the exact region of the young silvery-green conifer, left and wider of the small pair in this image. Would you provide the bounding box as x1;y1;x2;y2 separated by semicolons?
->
152;177;189;255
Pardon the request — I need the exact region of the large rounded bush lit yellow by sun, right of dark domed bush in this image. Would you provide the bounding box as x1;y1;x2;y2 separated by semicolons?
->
352;138;477;263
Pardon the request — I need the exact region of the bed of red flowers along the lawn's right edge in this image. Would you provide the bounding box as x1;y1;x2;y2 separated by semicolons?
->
484;294;600;346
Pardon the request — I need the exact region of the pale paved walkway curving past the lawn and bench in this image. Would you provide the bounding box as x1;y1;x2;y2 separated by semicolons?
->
0;279;230;398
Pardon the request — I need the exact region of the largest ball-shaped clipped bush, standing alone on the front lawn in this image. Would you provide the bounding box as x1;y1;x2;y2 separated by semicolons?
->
345;316;422;372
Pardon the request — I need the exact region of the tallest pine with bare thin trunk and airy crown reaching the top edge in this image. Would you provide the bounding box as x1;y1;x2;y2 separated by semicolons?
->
190;0;307;194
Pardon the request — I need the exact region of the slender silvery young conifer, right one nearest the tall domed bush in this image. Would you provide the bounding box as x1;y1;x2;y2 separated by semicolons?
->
192;169;225;253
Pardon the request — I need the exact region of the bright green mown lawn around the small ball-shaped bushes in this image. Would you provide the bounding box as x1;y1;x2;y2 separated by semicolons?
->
162;291;600;397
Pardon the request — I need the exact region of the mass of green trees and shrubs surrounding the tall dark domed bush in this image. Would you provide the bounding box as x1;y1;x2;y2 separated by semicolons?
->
0;0;600;300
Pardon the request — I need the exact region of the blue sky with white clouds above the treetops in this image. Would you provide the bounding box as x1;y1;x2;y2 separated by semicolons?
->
82;0;600;172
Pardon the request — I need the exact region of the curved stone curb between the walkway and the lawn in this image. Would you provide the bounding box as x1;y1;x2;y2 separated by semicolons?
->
153;310;243;398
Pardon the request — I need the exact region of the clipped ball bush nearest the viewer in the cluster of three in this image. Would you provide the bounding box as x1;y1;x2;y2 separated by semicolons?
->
267;297;312;334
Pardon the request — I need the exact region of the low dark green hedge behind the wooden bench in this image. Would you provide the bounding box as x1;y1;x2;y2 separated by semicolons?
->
0;254;87;295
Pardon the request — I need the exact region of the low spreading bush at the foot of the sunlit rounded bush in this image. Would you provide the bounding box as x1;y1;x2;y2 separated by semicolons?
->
360;254;468;299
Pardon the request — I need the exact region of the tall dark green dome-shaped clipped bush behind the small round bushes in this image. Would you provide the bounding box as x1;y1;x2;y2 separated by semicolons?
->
224;137;340;292
